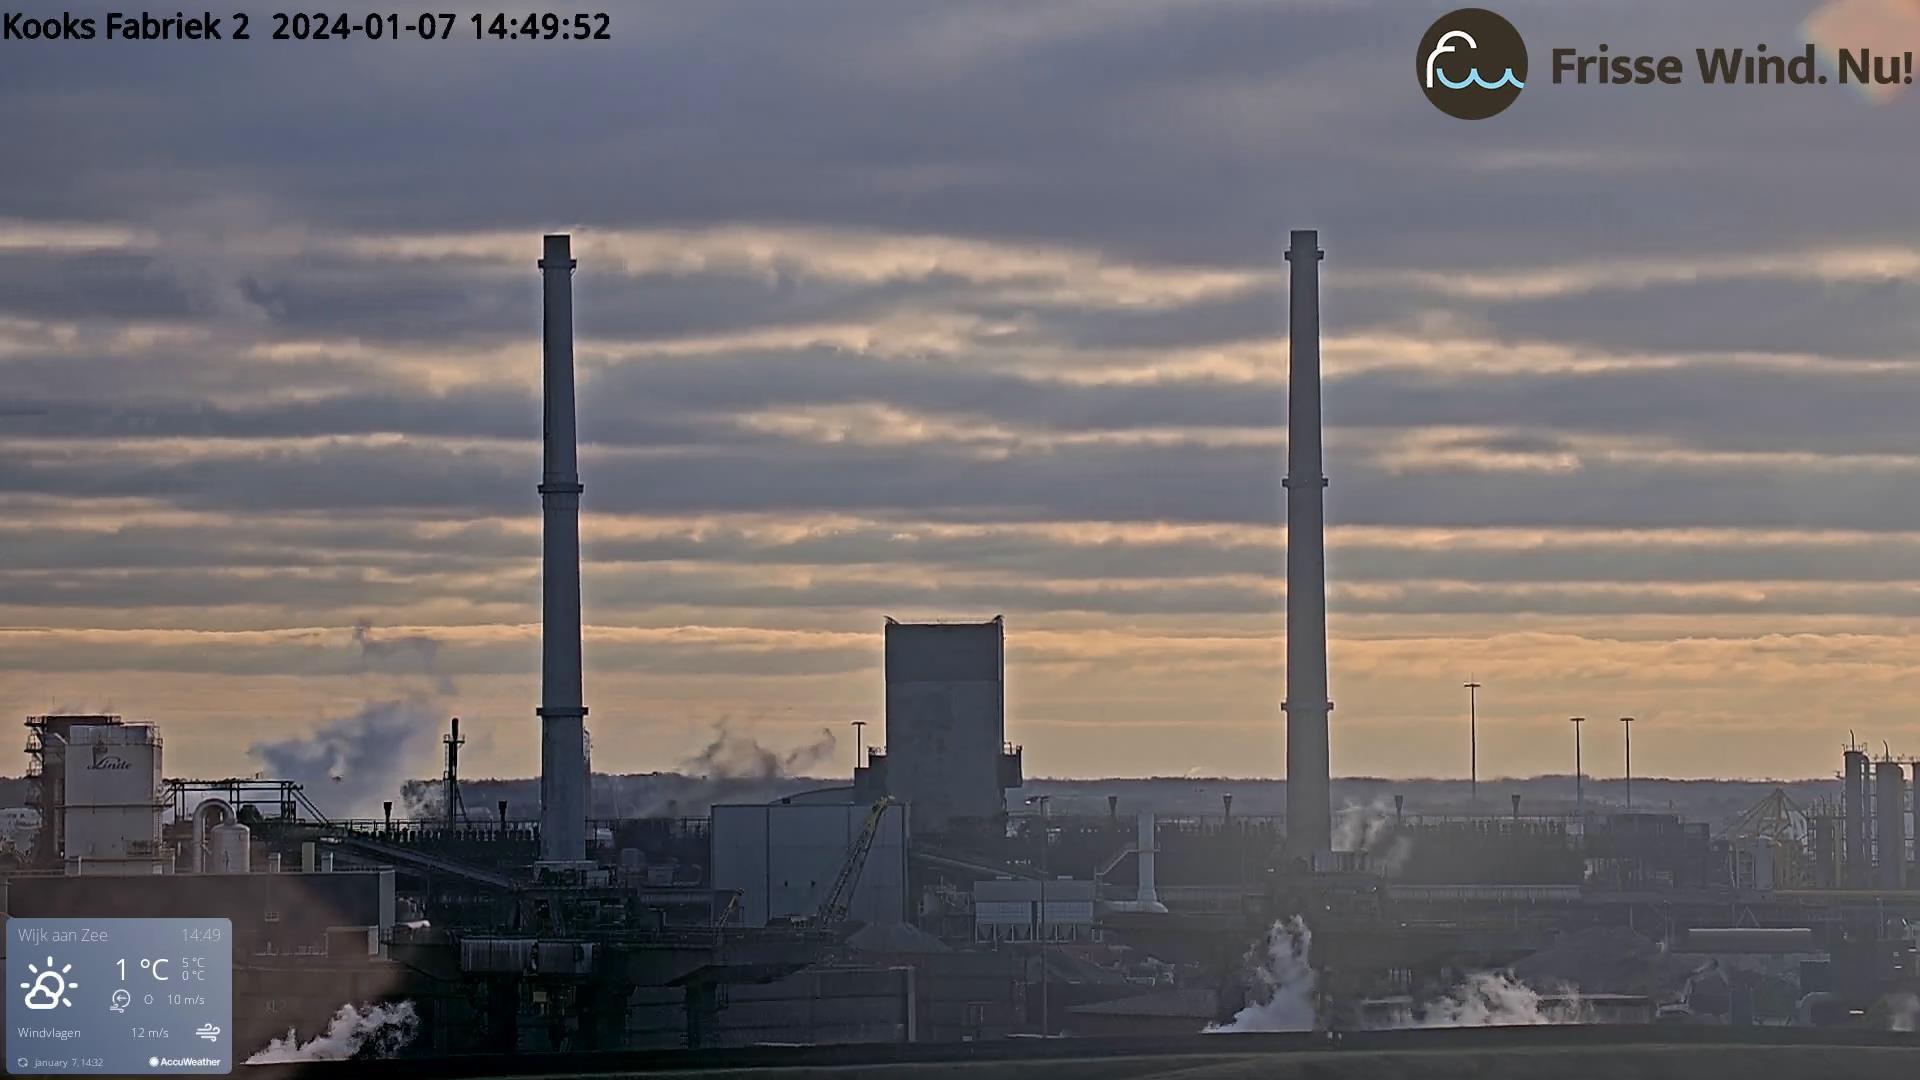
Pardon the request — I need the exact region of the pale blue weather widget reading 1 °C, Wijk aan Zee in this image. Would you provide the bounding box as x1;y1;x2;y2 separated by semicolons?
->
6;919;234;1074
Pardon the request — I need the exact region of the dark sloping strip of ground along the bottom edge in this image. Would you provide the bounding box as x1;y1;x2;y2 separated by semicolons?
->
236;1026;1920;1080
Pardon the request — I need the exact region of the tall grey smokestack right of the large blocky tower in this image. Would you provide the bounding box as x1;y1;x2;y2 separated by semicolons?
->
1281;229;1332;859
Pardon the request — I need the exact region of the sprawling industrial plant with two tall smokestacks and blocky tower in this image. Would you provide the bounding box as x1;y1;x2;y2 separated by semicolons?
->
0;231;1920;1055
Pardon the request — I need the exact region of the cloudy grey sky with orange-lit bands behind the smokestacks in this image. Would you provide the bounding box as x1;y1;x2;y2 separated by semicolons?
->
0;0;1920;776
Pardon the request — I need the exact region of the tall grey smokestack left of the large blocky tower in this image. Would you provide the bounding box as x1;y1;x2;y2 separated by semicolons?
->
540;234;588;863
